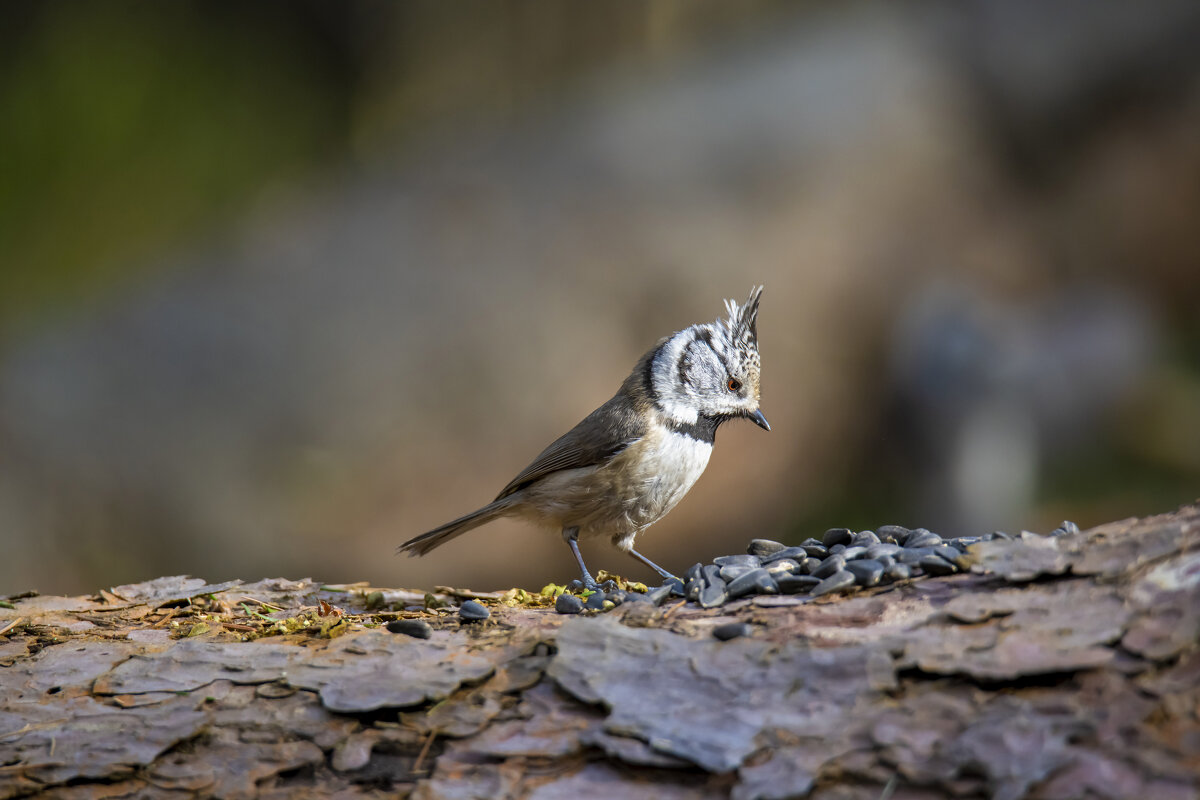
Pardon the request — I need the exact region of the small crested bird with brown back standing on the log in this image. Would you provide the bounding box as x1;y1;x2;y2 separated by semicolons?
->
398;285;770;591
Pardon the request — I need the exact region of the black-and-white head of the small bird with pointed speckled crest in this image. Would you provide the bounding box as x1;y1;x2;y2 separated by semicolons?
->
650;287;762;429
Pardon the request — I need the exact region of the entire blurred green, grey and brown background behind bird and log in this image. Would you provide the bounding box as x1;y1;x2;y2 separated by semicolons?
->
0;0;1200;595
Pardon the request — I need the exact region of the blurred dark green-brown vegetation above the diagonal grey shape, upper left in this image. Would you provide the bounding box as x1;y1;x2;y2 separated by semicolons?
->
0;0;782;345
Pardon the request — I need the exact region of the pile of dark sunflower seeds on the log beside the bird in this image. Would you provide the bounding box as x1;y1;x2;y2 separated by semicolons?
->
580;522;1079;613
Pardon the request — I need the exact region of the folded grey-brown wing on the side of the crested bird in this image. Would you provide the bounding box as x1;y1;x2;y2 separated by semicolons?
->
496;393;646;500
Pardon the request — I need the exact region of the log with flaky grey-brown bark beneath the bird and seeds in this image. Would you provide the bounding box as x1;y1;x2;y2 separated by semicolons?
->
0;506;1200;800
